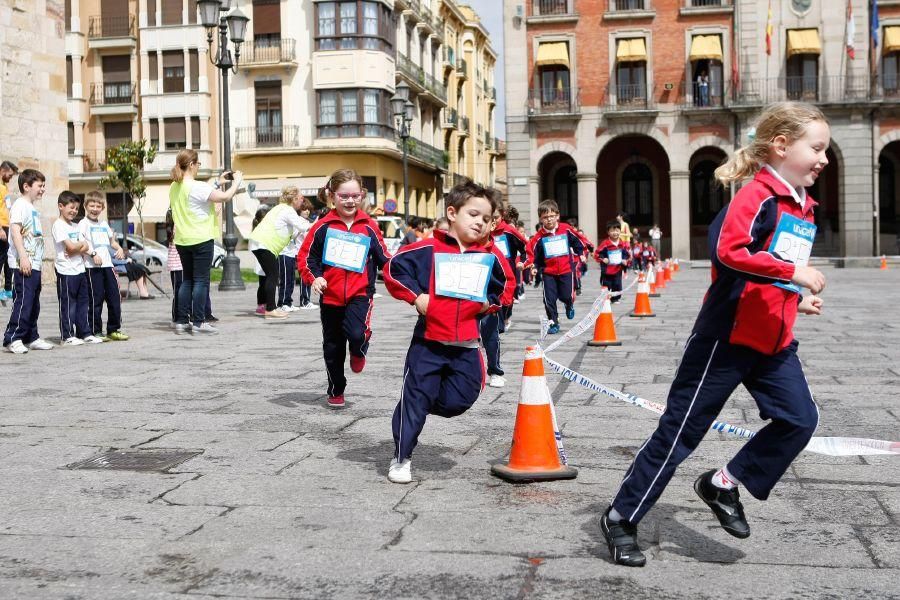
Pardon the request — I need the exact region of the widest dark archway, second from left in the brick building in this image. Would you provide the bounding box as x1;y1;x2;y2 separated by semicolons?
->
597;135;671;253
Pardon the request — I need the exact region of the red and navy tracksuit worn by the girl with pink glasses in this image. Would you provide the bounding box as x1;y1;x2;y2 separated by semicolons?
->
297;210;391;397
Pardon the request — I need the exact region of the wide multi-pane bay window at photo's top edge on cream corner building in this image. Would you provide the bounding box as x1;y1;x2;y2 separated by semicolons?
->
316;0;394;52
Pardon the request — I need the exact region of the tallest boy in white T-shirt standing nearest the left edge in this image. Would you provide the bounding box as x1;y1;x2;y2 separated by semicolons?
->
3;169;53;354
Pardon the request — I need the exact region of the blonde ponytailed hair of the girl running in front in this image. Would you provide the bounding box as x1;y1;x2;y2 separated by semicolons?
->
715;102;828;185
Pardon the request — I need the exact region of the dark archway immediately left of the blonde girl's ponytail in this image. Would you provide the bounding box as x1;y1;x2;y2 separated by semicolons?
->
689;146;729;259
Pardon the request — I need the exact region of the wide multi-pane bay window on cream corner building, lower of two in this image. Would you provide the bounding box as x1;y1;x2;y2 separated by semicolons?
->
317;89;393;139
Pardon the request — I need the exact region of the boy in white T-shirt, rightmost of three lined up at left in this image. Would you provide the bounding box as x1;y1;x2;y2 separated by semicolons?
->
78;191;128;342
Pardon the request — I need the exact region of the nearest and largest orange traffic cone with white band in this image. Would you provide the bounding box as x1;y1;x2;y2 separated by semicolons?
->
491;346;578;483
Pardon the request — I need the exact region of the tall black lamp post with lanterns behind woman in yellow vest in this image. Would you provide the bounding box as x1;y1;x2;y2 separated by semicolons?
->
197;0;250;291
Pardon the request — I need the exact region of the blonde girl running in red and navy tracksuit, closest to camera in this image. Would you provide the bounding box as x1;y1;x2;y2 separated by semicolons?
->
600;102;830;566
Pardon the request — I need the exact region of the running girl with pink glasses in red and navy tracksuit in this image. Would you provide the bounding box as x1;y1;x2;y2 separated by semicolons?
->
297;169;390;408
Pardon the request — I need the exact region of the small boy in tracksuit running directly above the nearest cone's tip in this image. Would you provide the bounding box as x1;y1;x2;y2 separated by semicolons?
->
525;200;584;333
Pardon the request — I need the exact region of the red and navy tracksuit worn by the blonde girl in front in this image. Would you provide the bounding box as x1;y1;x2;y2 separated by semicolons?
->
612;167;819;523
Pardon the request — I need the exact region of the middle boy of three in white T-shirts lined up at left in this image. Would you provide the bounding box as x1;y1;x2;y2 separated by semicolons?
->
52;190;103;346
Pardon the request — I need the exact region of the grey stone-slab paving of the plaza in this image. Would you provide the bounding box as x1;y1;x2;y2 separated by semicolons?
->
0;268;900;600
